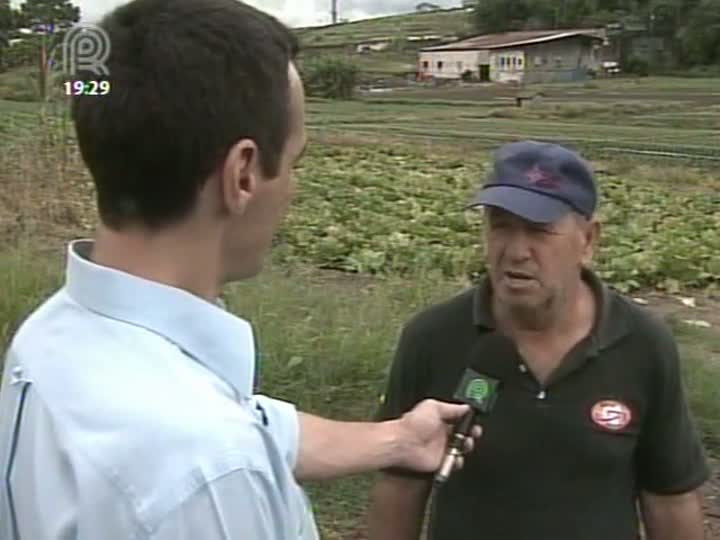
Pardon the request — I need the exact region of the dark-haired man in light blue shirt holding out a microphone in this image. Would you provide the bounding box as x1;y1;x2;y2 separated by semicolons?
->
0;0;479;540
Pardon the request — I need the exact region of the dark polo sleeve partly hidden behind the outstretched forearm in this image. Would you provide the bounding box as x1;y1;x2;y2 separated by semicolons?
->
374;324;430;478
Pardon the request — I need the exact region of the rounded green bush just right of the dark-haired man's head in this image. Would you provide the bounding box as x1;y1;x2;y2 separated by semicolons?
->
301;56;359;99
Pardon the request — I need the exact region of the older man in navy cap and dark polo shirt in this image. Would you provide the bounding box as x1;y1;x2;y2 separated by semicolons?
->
370;141;708;540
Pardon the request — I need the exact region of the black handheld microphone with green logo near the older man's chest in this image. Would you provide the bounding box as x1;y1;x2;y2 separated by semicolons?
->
435;356;500;484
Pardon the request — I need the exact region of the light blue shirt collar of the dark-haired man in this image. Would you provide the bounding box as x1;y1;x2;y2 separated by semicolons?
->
65;240;255;398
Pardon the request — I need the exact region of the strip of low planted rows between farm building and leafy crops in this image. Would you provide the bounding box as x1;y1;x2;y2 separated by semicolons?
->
309;78;720;161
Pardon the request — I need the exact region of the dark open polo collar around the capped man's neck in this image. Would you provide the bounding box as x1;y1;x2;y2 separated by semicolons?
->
473;268;630;356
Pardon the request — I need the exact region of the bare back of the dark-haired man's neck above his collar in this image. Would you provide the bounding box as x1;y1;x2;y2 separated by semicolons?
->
90;226;221;301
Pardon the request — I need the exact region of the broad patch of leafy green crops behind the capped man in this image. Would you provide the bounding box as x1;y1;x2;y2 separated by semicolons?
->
278;141;720;291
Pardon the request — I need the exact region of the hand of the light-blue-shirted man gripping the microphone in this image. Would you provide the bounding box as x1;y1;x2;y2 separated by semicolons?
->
394;399;482;472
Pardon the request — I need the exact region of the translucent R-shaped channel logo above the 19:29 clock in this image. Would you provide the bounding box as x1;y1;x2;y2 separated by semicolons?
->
62;24;110;77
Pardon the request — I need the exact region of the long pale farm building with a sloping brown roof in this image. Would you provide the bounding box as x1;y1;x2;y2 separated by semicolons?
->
418;29;606;83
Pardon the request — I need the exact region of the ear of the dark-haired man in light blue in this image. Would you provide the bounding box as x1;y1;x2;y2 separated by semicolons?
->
220;139;259;214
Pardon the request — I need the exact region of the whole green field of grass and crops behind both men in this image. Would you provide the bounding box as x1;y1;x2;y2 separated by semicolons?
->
0;74;720;540
